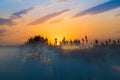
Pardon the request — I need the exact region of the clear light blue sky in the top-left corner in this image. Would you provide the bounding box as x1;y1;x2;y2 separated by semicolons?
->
0;0;48;16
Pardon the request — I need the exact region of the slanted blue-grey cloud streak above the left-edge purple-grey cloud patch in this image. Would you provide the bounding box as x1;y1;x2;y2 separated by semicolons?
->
11;7;33;18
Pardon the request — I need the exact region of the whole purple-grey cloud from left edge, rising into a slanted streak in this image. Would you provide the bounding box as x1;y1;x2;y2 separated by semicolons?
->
0;7;33;26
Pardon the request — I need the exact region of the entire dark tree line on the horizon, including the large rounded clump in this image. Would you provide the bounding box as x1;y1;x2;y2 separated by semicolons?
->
25;35;120;47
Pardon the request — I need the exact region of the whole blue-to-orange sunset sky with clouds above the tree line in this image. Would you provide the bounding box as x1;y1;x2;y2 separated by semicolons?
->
0;0;120;45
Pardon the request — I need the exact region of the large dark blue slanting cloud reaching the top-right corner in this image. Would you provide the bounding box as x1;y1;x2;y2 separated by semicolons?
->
74;0;120;17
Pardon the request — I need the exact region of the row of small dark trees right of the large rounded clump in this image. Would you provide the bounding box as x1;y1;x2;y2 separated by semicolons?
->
55;36;120;47
